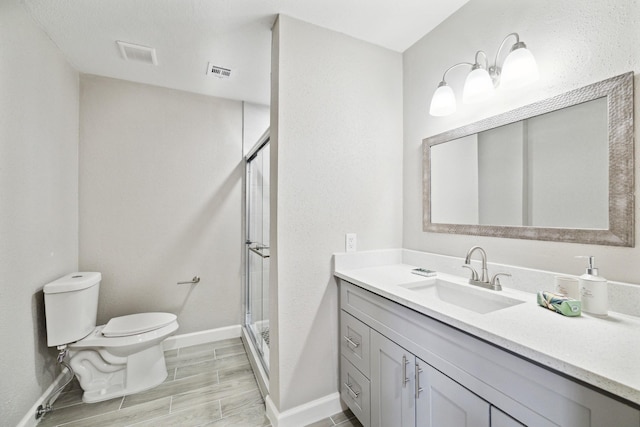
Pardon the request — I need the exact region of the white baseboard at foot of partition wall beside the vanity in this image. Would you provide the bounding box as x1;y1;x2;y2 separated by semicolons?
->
265;392;347;427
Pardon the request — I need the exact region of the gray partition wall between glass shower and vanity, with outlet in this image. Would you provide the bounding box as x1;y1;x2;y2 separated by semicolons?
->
270;16;402;411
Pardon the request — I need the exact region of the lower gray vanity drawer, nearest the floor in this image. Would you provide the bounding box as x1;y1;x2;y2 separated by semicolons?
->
340;356;371;427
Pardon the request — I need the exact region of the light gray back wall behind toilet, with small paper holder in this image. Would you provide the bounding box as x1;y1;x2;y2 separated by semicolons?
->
80;76;244;334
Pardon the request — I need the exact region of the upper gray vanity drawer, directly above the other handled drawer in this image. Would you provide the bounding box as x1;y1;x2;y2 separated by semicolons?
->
340;311;370;377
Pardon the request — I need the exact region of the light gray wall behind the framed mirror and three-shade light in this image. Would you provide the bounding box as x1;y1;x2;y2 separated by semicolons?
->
403;0;640;283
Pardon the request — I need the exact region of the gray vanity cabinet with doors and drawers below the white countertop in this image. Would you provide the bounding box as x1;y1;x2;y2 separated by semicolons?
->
340;280;640;427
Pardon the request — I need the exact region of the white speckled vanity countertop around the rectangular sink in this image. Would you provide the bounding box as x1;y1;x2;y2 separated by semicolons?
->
335;264;640;405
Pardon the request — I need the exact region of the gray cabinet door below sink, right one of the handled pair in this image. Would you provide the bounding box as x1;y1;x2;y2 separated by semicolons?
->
416;359;490;427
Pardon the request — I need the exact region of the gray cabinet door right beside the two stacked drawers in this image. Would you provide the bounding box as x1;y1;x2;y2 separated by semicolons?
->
371;330;416;427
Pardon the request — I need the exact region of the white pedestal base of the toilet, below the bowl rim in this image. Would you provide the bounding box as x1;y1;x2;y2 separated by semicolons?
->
71;343;167;403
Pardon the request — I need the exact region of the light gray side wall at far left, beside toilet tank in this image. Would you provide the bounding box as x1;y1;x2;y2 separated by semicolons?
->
0;0;78;426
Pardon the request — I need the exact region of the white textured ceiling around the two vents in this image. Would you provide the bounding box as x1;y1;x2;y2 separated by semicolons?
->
24;0;468;105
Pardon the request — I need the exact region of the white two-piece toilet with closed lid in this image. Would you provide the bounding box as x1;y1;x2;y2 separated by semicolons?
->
44;273;178;403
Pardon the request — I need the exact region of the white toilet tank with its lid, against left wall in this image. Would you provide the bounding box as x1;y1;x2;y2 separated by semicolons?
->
43;273;102;347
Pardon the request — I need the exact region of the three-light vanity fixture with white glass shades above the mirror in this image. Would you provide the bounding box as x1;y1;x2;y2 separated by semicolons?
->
429;33;538;116
